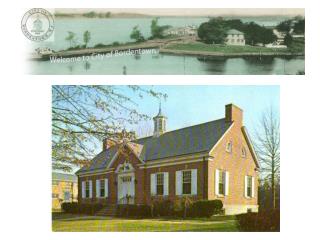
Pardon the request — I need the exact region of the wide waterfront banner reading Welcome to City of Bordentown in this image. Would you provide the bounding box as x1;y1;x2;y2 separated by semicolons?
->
22;8;305;75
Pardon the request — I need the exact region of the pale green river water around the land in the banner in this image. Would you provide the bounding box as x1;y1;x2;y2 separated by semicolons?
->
29;17;305;75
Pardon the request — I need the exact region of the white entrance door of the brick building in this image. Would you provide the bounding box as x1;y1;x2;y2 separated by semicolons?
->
118;174;134;204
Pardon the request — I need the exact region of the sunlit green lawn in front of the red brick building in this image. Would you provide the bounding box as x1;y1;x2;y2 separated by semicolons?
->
52;214;238;232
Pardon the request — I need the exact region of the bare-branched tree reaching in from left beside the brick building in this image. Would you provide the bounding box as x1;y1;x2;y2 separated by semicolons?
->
52;85;167;171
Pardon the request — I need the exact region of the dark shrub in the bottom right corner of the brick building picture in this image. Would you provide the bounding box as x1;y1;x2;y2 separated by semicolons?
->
237;210;280;232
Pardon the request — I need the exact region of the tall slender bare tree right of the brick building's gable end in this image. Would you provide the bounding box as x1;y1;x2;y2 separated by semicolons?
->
254;108;280;208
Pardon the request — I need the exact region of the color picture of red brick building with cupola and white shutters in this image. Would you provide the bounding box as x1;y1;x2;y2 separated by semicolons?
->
52;85;280;232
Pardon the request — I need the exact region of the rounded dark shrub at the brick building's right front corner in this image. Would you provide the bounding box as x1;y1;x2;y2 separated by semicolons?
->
189;200;223;218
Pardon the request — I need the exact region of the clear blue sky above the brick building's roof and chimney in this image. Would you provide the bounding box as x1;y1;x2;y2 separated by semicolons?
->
124;85;280;136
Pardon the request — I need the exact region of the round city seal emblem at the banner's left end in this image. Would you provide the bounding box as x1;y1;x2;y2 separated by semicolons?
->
21;8;54;42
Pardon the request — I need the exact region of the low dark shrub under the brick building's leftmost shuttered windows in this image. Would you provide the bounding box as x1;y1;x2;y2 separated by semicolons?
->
61;202;103;215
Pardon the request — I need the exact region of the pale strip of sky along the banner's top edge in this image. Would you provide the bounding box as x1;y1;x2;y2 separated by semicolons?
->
56;8;304;16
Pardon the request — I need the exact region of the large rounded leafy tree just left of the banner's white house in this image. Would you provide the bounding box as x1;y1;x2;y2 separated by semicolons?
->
198;18;227;44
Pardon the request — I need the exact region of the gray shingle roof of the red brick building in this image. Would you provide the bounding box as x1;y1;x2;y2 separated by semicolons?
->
77;118;232;173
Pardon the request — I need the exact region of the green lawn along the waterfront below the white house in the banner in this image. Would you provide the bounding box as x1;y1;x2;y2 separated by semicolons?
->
165;42;304;54
